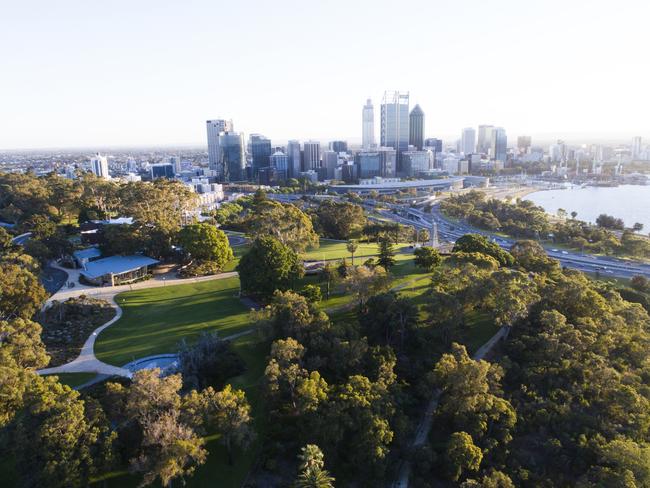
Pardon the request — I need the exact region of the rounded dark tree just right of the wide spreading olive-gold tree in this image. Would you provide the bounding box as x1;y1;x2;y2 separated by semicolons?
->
315;200;367;240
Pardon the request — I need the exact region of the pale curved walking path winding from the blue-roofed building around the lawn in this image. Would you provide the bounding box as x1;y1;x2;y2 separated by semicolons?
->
38;268;239;378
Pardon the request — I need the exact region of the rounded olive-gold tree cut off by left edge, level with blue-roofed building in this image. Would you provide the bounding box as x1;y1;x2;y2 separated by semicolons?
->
0;261;47;320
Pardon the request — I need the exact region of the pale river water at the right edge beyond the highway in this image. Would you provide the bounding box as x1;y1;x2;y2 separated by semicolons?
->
526;185;650;234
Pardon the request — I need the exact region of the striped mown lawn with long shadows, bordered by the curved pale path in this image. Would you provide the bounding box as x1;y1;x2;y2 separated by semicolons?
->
95;277;250;366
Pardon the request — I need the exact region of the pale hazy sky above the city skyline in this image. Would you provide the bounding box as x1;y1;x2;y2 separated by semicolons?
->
0;0;650;149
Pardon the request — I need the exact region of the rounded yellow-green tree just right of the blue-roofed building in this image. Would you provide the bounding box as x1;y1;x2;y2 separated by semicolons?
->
178;224;234;270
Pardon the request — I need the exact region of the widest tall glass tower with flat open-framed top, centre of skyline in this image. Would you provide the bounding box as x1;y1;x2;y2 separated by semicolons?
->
380;91;409;154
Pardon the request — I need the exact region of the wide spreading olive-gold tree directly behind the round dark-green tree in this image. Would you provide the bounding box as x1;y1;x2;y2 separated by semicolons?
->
247;200;318;252
